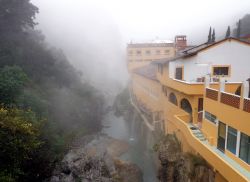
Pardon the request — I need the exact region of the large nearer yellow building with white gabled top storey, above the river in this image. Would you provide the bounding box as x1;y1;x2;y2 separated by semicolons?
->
129;38;250;181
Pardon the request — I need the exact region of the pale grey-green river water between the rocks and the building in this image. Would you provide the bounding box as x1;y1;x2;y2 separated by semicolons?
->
102;112;157;182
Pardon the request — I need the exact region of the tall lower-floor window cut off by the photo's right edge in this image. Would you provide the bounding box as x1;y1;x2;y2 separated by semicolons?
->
239;133;250;164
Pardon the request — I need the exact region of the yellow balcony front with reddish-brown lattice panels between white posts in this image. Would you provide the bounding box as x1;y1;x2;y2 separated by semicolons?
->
204;88;250;134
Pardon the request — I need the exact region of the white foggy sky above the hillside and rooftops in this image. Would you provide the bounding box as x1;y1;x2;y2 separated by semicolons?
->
32;0;250;92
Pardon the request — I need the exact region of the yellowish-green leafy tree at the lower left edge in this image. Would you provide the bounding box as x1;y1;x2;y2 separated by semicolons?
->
0;107;41;181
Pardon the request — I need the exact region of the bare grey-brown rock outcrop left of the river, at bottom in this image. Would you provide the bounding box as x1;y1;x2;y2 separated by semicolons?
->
50;135;142;182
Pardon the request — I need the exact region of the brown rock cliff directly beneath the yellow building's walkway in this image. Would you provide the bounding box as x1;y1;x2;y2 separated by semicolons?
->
157;135;215;182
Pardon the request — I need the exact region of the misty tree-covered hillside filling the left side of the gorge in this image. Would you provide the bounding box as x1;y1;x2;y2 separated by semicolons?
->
0;0;103;182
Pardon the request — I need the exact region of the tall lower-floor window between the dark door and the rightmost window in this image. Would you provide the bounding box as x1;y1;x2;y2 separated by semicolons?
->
227;126;237;154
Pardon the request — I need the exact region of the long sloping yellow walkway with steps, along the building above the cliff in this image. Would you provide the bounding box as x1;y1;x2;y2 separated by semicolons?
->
173;115;250;182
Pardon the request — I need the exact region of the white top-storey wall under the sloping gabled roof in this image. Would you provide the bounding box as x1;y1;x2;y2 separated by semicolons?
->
169;40;250;82
